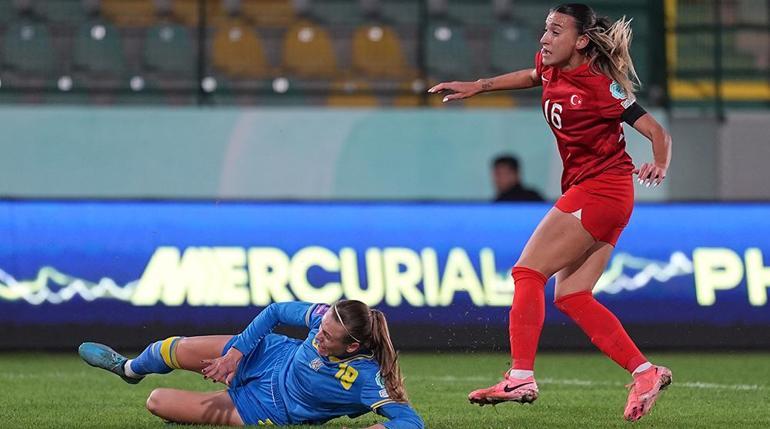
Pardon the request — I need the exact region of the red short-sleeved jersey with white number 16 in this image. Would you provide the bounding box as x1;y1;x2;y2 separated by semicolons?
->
535;51;635;192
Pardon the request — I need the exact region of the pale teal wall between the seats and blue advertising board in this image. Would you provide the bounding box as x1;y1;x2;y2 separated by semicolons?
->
0;107;666;200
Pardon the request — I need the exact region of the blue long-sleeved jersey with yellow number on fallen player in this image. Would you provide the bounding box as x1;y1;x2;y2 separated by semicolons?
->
231;302;423;429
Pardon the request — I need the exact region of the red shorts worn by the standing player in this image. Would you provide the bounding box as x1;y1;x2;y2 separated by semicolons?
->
555;174;634;246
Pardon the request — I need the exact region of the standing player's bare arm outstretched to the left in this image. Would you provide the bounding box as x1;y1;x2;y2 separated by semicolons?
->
428;69;541;103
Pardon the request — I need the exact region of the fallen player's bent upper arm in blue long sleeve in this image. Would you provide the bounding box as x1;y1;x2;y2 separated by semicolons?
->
228;302;329;354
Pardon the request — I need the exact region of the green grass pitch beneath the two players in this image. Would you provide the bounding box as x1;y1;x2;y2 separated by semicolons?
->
0;351;770;428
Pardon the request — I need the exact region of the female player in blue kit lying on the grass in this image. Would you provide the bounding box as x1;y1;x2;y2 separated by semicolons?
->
79;300;424;429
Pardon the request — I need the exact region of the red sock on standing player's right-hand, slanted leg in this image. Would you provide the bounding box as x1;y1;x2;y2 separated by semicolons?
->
555;291;647;372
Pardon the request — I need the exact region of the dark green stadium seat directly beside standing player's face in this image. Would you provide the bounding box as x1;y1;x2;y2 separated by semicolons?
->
490;23;540;74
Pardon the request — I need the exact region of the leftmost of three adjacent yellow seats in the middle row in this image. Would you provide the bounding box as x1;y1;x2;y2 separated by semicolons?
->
212;19;270;78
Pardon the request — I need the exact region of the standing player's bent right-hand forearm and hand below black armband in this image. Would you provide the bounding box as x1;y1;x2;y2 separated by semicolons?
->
633;113;671;186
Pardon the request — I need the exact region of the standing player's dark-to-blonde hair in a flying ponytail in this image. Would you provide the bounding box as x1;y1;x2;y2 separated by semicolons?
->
551;3;642;98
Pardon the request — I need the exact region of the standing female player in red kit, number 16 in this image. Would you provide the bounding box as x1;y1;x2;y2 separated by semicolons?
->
429;3;671;421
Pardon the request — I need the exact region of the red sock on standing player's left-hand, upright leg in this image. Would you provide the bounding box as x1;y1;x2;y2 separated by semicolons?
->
508;267;548;371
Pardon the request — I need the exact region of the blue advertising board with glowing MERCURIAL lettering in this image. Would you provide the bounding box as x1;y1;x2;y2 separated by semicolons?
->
0;201;770;344
